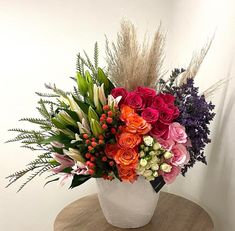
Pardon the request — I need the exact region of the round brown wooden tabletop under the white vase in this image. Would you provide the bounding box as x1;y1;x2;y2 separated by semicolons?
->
54;192;213;231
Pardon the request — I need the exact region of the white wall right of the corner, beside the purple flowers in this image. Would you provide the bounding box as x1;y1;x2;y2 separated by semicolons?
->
169;0;235;231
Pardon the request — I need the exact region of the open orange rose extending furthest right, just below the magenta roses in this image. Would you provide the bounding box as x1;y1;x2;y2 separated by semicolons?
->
126;114;151;135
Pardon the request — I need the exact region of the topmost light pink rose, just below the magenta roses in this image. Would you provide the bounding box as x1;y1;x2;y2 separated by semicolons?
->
168;122;187;143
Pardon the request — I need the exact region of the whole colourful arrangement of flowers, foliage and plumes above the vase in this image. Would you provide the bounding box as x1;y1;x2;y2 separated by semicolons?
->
5;21;215;191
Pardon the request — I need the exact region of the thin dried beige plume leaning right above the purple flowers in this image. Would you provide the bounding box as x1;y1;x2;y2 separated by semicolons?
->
179;36;214;86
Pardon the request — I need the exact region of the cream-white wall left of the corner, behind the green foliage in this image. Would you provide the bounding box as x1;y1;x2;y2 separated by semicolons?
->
0;0;170;231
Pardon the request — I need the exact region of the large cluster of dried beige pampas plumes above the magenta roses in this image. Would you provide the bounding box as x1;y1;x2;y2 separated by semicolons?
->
106;20;165;90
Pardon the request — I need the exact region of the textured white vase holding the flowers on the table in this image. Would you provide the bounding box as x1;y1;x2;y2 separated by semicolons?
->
96;177;159;228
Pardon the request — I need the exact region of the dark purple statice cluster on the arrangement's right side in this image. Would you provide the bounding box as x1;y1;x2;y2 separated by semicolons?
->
171;79;215;175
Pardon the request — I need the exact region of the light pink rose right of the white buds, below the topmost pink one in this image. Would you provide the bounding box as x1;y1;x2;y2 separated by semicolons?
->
171;144;190;166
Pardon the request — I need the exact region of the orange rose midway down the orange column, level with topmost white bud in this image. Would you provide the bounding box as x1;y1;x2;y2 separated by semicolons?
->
118;132;141;148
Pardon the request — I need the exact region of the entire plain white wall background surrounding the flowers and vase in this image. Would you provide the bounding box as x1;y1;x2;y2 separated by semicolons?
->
0;0;235;231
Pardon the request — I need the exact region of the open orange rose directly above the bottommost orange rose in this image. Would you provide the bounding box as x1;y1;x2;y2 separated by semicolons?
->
114;148;139;166
